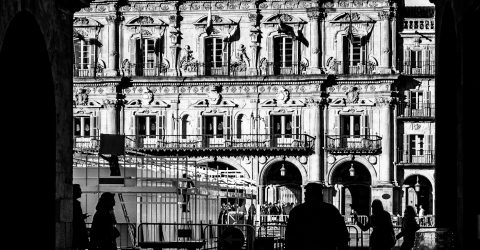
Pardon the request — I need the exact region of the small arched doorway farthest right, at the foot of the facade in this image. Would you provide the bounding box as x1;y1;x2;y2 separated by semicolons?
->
403;175;433;214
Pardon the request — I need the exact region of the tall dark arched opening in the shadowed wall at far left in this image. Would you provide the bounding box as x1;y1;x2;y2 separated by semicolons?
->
0;12;55;249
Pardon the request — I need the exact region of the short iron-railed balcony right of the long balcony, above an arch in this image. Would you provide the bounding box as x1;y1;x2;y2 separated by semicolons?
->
325;135;382;154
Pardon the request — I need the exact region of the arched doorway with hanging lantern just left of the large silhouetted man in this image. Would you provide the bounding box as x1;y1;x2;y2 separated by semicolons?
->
260;161;302;204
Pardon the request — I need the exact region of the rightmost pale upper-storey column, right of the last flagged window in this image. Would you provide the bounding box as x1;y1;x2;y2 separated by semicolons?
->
377;11;392;74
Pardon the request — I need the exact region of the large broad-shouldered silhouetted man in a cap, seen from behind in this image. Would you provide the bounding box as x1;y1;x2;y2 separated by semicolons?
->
285;183;350;250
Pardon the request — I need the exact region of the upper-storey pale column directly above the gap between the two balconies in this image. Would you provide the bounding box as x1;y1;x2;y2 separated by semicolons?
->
307;7;324;74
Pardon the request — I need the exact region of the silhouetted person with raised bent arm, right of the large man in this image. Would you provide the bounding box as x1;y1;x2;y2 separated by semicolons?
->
354;200;395;250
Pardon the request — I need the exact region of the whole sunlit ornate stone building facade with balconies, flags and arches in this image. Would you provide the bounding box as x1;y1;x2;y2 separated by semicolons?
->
73;0;435;222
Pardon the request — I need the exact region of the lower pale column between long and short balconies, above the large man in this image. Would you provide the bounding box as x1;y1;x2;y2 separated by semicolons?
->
309;101;323;182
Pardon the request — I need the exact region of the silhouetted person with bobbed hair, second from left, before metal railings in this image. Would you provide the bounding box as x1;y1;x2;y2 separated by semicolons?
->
90;192;120;250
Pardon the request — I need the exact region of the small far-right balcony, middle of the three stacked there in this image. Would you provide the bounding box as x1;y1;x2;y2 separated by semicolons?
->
397;103;435;120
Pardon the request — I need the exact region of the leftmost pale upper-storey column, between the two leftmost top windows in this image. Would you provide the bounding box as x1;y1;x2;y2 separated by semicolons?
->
105;14;120;76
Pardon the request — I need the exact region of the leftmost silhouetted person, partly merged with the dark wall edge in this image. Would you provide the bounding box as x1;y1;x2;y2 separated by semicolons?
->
72;184;88;250
